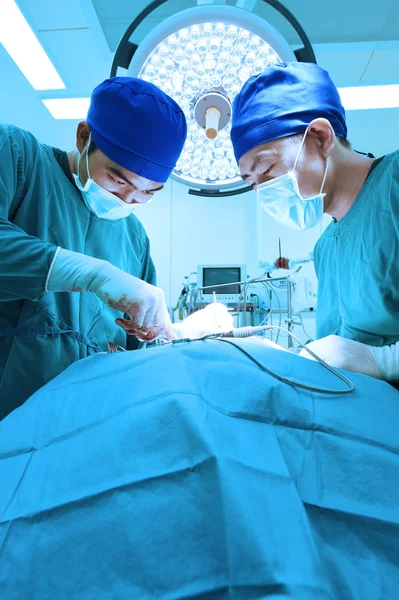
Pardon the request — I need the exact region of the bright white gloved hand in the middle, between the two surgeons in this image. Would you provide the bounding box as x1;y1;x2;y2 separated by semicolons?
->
172;302;234;339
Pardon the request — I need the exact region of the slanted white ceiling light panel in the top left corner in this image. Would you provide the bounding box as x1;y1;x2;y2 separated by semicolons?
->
0;0;65;90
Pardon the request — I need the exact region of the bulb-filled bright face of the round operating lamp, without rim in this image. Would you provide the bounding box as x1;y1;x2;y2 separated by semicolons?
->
138;21;281;187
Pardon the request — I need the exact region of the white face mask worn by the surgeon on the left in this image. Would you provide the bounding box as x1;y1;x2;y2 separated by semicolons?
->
73;134;149;221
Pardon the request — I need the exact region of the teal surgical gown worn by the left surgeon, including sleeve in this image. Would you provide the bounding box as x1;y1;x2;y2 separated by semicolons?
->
0;125;155;419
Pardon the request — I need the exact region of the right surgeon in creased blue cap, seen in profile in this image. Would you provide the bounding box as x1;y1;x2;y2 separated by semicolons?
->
231;62;399;382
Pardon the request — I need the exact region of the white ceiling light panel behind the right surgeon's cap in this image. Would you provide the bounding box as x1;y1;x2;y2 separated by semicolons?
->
338;84;399;110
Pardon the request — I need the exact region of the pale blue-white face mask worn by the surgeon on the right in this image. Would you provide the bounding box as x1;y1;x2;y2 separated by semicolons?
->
257;130;329;230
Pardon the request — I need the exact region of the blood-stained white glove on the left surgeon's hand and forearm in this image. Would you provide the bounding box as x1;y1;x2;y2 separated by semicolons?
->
46;248;173;341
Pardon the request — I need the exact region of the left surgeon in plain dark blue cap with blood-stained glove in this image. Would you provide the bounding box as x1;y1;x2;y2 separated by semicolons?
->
0;77;187;418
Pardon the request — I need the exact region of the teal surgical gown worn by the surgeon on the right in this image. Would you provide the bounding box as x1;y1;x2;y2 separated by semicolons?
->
314;151;399;346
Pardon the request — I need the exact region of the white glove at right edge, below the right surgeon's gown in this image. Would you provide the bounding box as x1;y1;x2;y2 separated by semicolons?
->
299;335;382;379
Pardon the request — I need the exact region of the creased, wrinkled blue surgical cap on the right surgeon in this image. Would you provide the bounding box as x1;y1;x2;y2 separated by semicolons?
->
231;62;347;162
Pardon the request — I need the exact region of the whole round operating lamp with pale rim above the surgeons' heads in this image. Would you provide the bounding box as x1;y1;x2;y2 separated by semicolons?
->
111;1;315;196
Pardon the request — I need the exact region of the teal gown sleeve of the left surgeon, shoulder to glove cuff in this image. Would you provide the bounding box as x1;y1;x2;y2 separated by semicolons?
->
0;126;57;302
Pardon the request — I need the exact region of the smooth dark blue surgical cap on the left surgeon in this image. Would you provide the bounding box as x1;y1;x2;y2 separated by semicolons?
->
87;77;187;183
